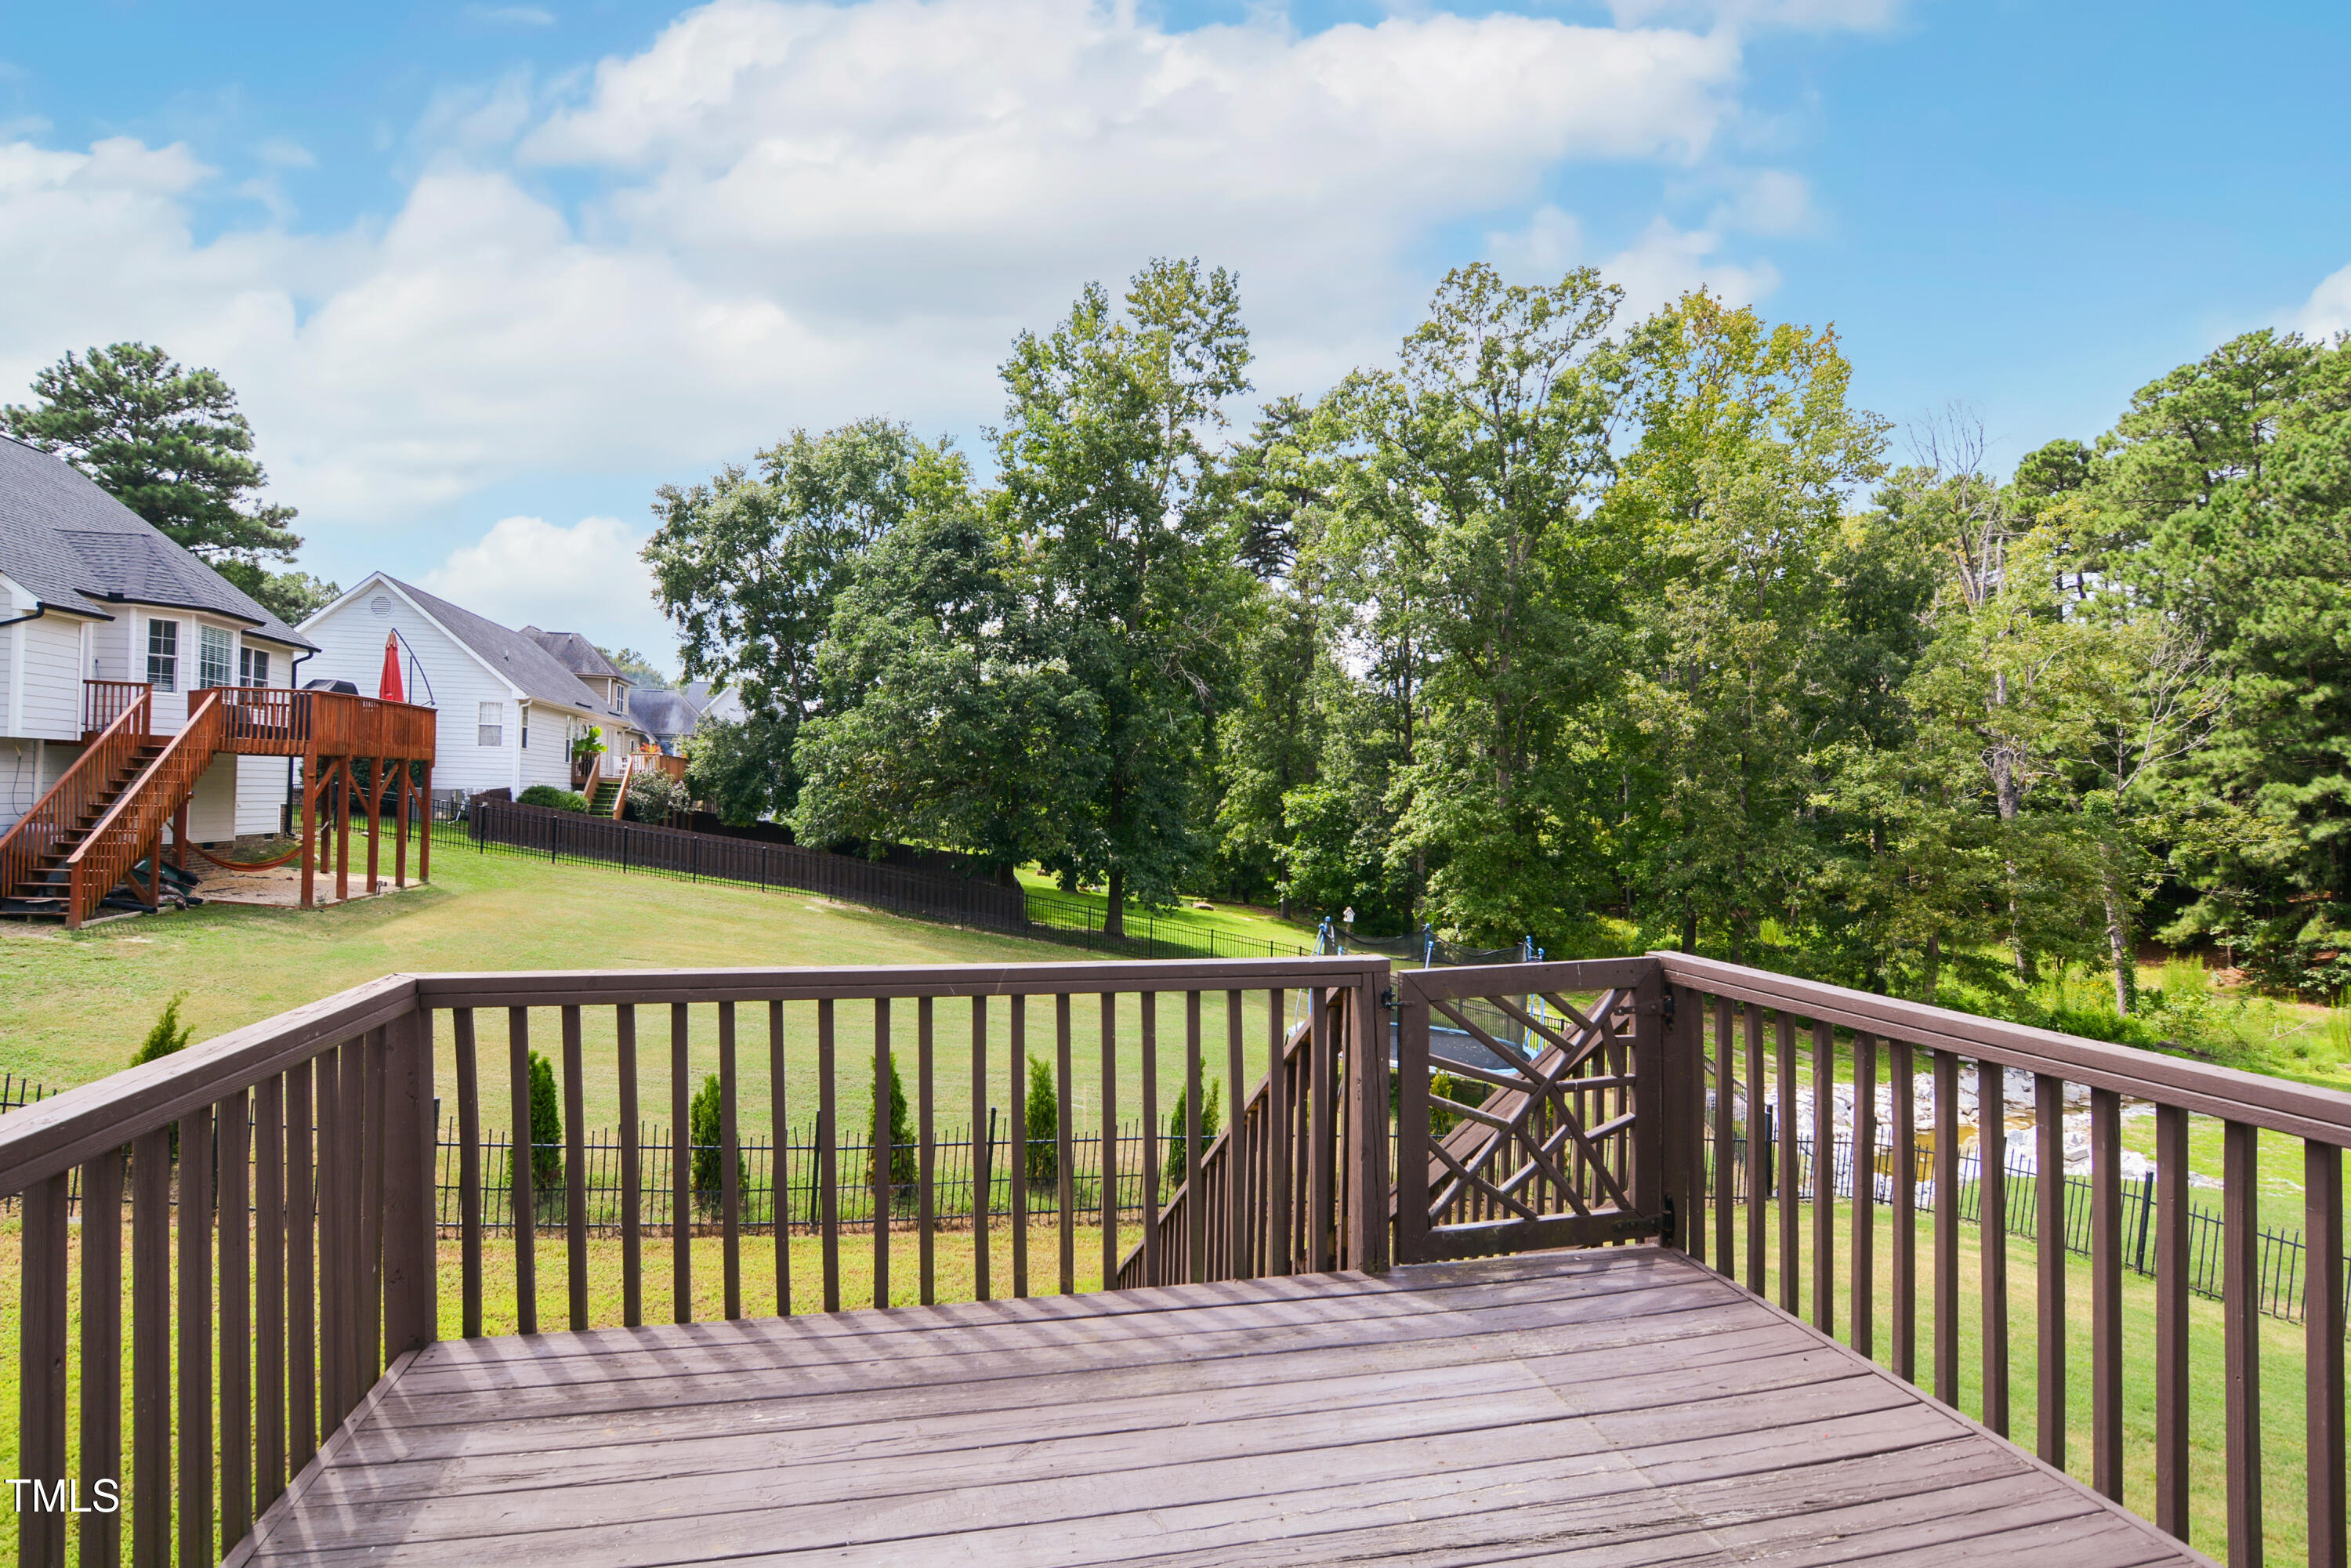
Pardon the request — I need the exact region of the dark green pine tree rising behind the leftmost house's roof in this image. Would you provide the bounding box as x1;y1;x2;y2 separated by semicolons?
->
0;343;339;621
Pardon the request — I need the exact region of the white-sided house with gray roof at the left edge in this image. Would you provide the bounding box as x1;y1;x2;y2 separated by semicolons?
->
0;437;317;846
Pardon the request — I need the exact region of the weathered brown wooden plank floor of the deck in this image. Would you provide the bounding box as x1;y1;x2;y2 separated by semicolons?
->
230;1246;2208;1568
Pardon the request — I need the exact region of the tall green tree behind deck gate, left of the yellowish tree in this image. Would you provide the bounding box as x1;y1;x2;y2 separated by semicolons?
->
1333;263;1622;933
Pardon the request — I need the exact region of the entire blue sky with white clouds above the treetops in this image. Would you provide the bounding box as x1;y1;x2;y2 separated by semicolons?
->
0;0;2351;649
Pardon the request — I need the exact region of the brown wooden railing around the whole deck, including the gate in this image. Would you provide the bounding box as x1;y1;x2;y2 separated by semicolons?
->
0;954;2351;1563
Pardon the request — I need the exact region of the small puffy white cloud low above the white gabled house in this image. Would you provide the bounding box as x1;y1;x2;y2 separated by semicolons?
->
423;517;672;649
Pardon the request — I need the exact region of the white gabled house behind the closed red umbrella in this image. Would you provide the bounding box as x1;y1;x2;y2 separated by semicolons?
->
301;571;614;795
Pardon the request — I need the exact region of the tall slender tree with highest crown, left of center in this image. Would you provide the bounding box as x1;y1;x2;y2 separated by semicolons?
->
992;261;1248;936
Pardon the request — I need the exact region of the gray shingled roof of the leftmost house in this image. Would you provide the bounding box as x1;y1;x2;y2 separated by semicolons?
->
0;435;313;649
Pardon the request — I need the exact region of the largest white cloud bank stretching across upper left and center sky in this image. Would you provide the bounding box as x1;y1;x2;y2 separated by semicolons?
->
0;0;1801;576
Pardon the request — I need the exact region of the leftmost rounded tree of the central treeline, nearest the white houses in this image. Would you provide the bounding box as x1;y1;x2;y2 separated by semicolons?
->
644;418;924;811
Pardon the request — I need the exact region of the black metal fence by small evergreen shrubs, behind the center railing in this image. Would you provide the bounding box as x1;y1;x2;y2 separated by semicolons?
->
435;1119;1208;1237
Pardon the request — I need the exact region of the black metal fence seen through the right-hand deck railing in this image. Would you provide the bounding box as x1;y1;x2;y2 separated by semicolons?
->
1730;1138;2351;1324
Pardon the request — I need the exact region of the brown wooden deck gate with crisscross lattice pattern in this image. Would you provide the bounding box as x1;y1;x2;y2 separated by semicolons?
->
1396;961;1672;1262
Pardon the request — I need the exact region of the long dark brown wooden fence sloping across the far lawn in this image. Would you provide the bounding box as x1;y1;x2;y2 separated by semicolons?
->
468;797;1027;931
